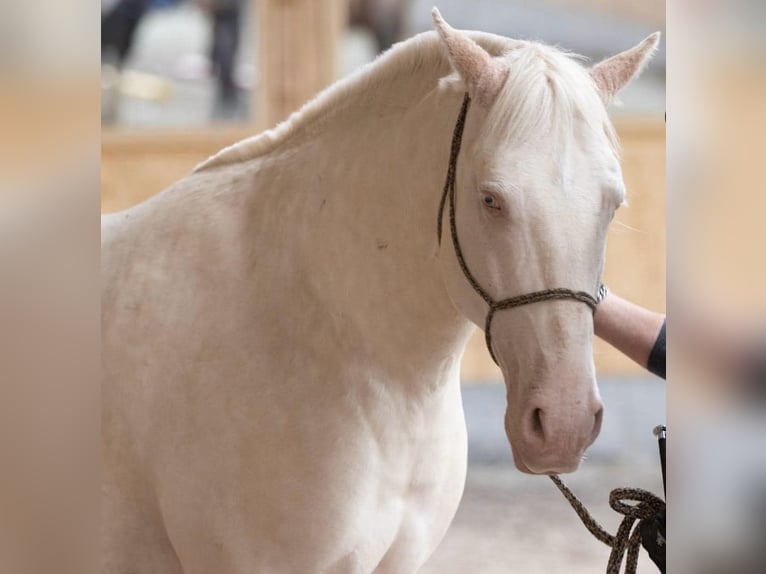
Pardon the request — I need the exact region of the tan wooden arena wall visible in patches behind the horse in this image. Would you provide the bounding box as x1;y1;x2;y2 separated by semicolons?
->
101;118;665;379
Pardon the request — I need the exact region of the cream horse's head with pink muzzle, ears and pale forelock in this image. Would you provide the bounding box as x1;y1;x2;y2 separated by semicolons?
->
434;9;659;473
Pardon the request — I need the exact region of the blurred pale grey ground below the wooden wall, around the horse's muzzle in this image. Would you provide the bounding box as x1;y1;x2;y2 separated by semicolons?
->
421;378;665;574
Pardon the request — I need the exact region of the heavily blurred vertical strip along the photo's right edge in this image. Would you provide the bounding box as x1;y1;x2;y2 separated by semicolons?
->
668;0;766;574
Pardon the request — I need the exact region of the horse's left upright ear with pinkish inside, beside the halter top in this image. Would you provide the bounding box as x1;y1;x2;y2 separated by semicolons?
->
431;8;508;107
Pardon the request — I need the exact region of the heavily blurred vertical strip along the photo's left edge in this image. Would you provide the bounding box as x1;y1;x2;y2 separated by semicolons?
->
0;0;100;574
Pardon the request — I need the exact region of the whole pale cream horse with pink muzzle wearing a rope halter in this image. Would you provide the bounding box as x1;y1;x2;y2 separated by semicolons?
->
102;11;658;574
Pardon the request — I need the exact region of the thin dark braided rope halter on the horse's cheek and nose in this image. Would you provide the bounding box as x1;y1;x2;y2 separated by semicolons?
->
437;94;600;364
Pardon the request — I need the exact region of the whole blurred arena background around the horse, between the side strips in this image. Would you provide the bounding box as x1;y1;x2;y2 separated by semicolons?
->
101;0;666;574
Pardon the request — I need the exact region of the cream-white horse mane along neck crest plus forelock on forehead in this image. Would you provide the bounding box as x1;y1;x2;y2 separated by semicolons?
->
194;31;617;173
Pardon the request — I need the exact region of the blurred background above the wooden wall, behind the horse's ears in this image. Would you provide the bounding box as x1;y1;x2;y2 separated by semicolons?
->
101;0;665;128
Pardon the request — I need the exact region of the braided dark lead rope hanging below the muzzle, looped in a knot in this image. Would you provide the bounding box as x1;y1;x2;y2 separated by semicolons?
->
550;475;665;574
